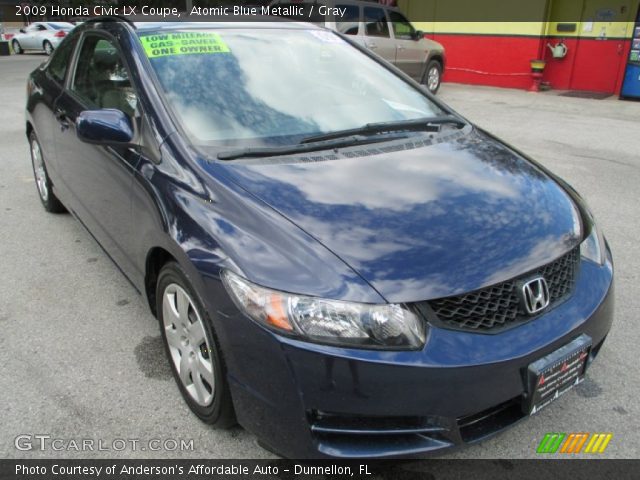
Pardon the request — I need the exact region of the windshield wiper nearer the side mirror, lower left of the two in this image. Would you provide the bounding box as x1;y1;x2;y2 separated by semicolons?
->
218;134;406;160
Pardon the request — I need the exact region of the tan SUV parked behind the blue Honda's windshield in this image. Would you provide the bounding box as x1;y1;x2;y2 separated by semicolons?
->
270;0;445;94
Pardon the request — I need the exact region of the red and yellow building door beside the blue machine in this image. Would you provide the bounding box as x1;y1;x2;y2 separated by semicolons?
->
570;0;632;94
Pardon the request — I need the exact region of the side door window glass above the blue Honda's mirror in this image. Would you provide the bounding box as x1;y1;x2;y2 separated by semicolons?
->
71;36;136;115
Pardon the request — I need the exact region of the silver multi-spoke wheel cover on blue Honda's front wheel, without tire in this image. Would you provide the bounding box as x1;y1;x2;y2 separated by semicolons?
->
162;283;215;407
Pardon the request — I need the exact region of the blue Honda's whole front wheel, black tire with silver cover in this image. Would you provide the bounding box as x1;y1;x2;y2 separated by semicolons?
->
156;262;236;428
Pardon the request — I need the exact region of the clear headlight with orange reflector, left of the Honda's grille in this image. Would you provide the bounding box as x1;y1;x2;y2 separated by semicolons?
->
222;270;425;350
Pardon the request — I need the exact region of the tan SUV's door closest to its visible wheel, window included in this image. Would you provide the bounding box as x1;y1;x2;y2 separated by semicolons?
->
387;10;427;80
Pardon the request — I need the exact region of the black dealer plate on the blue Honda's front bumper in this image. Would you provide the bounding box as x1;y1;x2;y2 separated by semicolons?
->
528;334;591;415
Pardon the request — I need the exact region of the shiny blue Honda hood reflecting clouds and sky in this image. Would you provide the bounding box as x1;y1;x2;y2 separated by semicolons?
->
208;129;581;302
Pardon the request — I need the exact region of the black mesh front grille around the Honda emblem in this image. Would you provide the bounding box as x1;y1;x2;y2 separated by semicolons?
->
418;247;580;331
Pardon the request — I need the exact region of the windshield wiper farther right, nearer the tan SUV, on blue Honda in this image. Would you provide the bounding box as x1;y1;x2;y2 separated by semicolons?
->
300;115;466;144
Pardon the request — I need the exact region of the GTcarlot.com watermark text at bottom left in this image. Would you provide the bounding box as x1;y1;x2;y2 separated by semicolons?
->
13;433;194;452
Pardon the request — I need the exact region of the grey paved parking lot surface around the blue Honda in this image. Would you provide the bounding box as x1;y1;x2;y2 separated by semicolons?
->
0;54;640;458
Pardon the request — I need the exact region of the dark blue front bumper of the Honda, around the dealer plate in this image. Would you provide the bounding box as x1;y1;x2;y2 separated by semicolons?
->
208;251;614;458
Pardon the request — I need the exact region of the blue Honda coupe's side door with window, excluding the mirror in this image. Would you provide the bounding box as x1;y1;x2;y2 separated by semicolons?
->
55;32;141;280
